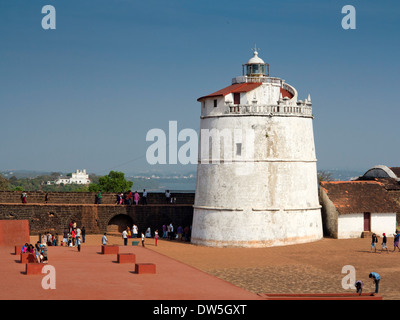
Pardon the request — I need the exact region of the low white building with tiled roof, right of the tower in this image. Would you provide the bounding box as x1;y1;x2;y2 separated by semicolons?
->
320;180;400;239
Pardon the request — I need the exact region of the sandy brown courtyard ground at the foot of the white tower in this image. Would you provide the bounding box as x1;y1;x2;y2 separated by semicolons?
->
39;235;400;300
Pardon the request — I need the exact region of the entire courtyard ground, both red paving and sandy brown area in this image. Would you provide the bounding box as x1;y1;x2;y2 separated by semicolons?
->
0;235;400;300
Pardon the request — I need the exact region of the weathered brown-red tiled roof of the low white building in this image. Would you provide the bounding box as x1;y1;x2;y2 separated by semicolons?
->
321;181;400;214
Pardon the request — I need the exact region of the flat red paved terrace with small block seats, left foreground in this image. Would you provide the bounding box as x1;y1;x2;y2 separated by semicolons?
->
0;245;261;300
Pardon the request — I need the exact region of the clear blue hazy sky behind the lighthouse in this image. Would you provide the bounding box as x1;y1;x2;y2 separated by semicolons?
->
0;0;400;174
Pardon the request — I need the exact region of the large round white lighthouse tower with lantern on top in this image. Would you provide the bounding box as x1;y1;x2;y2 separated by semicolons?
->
192;48;323;247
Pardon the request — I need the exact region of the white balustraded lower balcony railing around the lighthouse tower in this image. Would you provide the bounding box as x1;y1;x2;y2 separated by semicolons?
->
227;104;313;117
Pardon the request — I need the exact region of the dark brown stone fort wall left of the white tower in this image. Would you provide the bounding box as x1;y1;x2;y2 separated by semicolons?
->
0;191;194;235
